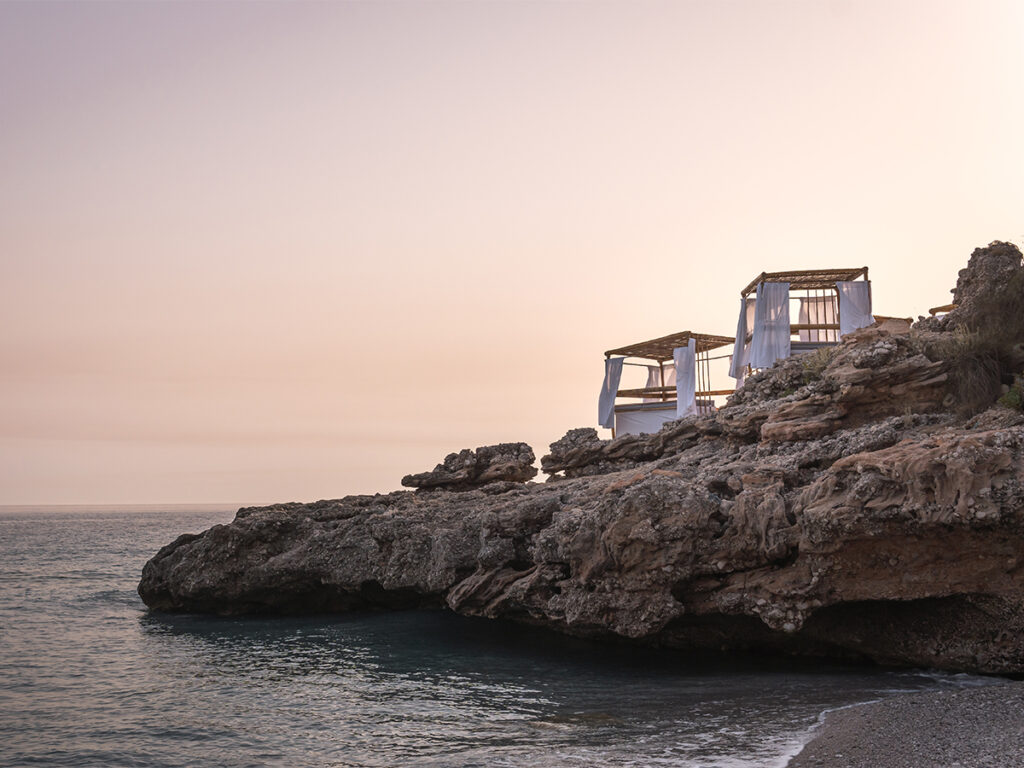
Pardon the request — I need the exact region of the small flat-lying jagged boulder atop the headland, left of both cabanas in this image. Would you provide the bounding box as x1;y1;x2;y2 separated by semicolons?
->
401;442;537;490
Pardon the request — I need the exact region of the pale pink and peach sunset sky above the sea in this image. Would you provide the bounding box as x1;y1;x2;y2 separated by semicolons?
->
0;0;1024;505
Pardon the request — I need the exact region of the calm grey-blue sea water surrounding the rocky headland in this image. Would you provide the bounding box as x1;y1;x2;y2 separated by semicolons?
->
0;507;985;768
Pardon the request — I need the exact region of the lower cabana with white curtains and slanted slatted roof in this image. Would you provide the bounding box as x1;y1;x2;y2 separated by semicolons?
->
598;331;734;436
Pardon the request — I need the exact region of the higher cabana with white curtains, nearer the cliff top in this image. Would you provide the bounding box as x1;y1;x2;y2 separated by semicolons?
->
729;266;874;386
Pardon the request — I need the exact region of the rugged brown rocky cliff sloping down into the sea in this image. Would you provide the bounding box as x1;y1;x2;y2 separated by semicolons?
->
139;243;1024;673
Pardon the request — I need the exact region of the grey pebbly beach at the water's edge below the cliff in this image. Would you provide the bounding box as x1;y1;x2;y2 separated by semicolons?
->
788;682;1024;768
